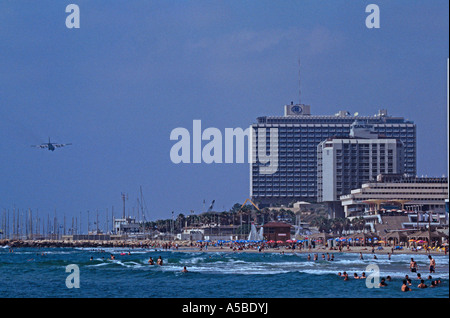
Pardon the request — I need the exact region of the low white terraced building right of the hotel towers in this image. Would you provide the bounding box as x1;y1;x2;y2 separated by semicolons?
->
340;174;448;226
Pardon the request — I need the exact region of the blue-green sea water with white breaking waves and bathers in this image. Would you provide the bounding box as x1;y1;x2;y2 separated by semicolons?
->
0;247;449;298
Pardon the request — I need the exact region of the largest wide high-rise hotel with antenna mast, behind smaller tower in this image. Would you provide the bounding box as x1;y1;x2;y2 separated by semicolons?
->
250;103;416;207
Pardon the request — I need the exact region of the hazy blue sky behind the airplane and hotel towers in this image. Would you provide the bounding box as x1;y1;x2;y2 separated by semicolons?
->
0;0;449;229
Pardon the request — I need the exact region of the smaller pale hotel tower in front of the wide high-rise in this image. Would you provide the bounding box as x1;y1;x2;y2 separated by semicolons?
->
317;121;404;218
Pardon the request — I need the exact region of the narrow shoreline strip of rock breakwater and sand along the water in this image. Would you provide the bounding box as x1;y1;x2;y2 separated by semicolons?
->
0;239;447;255
